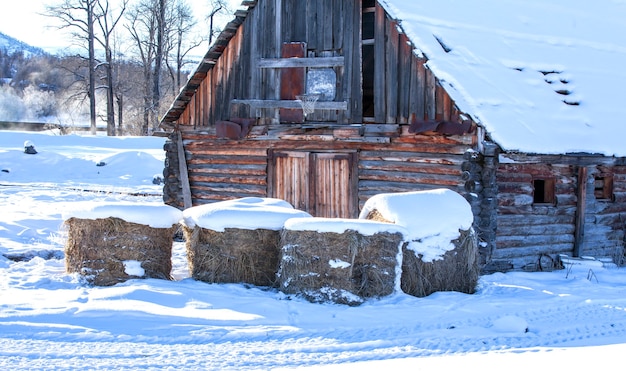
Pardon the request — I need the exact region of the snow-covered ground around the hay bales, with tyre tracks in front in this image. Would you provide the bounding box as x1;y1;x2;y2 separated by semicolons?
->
0;131;626;370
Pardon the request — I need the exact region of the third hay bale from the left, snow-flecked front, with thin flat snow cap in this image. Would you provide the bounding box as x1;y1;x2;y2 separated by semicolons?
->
278;218;404;305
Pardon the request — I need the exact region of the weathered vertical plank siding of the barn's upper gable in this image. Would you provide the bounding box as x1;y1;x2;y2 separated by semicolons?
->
164;0;460;130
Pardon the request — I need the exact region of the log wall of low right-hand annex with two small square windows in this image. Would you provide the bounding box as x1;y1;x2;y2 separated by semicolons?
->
487;154;626;270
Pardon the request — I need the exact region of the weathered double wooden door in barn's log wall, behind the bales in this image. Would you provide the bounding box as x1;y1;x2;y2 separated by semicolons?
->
269;151;358;218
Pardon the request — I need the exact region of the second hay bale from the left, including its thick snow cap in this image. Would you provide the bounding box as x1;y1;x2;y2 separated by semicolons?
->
183;197;310;286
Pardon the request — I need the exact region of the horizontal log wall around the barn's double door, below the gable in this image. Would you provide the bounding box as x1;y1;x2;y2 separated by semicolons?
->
164;132;474;212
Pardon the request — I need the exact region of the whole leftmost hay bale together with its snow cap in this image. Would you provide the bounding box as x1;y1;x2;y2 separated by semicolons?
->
65;204;182;286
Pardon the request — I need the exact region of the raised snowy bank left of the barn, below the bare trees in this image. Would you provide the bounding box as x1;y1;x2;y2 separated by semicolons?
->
0;131;166;194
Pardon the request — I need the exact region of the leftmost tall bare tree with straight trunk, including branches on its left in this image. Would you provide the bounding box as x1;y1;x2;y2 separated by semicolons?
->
46;0;98;135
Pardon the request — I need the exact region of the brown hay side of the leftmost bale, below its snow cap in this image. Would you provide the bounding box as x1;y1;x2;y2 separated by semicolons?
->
65;217;176;286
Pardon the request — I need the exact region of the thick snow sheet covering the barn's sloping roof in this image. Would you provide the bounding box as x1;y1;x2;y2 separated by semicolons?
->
381;0;626;156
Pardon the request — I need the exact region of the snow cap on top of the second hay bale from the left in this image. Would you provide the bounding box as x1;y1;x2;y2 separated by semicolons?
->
183;197;311;232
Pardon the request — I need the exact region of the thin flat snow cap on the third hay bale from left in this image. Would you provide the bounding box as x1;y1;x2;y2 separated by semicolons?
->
285;218;407;236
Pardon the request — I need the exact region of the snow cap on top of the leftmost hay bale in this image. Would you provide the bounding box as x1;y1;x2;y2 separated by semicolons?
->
62;202;183;228
